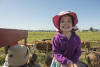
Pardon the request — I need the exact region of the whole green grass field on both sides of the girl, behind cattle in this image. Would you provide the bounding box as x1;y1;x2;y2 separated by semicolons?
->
0;32;100;66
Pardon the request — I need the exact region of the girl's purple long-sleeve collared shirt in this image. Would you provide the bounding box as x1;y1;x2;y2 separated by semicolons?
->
52;32;81;64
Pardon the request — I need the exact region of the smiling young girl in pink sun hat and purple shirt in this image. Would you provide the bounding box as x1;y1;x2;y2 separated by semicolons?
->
51;11;81;67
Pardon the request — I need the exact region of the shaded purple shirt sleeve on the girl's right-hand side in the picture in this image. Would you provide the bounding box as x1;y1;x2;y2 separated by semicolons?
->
72;38;81;63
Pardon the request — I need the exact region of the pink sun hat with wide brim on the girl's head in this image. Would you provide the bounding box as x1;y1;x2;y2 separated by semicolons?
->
53;10;78;29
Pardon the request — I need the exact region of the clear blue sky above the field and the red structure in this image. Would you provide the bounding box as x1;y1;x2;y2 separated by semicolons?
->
0;0;100;30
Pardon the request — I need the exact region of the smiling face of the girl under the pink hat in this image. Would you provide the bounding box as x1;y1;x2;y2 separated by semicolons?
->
60;15;73;32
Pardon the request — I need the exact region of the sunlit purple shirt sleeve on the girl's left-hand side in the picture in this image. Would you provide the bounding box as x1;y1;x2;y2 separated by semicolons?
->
52;37;70;64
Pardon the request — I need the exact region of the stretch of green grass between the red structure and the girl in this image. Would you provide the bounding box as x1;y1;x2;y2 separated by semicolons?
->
27;32;55;43
